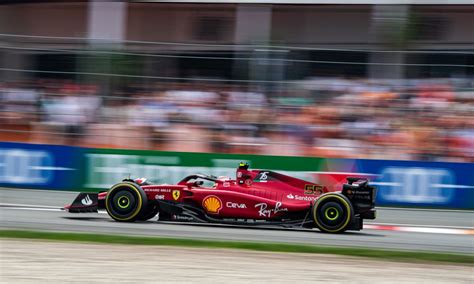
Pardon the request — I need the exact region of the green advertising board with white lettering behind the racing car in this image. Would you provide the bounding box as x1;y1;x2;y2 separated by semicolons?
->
82;149;325;190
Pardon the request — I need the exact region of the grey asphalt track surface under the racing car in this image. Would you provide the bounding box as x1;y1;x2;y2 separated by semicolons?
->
0;189;474;254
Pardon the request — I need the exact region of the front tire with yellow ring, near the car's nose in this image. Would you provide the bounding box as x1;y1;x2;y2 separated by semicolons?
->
105;181;148;222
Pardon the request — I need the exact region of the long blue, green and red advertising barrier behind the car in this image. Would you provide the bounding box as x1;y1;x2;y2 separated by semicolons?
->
0;143;474;209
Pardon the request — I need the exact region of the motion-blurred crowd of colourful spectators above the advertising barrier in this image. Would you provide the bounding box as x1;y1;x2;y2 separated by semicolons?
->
0;78;474;162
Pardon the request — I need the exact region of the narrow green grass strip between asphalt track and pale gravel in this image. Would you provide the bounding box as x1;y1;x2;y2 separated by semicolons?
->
0;230;474;265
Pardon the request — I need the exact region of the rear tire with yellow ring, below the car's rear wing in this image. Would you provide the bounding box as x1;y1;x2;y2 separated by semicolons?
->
311;192;354;233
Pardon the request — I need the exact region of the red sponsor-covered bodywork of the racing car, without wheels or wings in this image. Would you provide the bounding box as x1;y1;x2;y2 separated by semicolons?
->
93;167;328;219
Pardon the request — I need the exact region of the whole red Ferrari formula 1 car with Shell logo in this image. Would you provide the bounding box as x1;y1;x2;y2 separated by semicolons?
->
65;164;376;233
